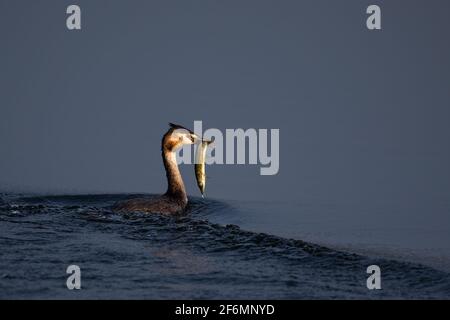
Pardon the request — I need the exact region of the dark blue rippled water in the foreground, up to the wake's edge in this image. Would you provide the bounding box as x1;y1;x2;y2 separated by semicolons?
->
0;194;450;299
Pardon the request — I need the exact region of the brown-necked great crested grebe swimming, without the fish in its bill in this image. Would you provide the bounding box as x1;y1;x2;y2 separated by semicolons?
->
113;123;198;214
